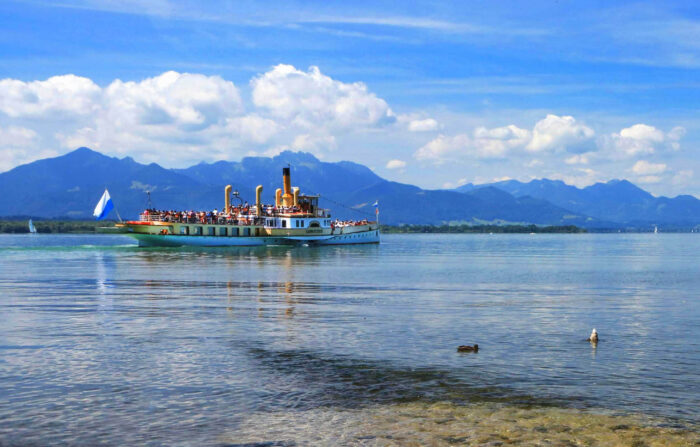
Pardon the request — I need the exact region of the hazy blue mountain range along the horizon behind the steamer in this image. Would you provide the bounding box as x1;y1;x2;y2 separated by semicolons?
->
0;147;700;229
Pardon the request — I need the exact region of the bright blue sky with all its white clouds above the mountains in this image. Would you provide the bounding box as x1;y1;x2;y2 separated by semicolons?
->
0;0;700;197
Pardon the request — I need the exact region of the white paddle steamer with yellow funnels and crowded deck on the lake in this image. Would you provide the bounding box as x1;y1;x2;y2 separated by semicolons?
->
118;167;379;247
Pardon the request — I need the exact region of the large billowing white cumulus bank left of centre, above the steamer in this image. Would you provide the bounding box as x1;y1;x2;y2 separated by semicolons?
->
0;65;404;166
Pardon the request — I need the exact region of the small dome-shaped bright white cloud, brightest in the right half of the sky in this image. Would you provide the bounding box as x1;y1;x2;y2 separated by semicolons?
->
525;115;595;152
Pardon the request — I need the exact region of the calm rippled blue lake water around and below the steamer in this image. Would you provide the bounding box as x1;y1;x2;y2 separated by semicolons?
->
0;234;700;446
